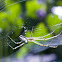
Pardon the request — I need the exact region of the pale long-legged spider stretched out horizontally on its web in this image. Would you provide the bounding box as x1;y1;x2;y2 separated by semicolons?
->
8;30;62;49
